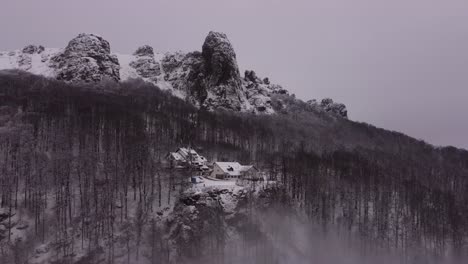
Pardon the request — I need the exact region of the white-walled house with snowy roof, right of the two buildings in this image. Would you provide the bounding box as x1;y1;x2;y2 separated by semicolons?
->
211;162;259;180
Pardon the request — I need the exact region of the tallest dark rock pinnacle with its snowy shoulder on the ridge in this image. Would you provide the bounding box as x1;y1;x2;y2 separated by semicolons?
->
162;32;251;111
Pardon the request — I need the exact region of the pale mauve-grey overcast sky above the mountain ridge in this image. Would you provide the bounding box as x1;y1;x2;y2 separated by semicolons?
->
0;0;468;149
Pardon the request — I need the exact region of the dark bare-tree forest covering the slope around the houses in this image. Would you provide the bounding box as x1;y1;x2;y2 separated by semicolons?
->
0;71;468;263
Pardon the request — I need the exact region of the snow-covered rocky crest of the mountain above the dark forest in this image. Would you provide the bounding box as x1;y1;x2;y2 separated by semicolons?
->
0;32;347;118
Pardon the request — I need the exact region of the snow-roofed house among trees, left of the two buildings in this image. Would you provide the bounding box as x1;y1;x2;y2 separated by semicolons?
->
167;148;209;170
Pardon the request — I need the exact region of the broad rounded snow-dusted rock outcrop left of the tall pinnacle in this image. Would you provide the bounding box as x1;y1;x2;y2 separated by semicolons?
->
51;34;120;82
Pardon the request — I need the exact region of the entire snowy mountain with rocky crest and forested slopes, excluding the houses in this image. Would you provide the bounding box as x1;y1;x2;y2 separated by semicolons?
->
0;33;468;264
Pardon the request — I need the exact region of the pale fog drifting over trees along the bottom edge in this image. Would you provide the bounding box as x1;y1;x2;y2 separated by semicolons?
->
188;208;468;264
